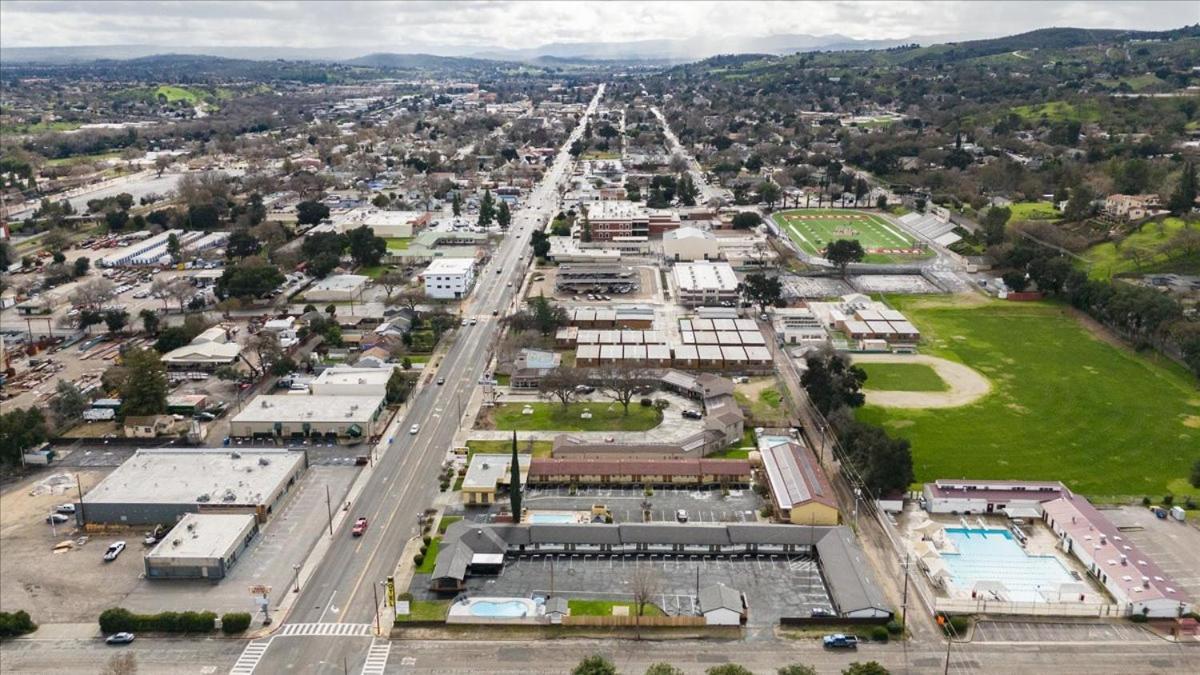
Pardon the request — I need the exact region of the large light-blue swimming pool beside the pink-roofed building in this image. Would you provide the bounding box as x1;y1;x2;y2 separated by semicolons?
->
942;527;1078;602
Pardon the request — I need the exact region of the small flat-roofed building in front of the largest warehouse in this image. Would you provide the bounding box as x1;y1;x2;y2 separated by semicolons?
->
144;513;258;580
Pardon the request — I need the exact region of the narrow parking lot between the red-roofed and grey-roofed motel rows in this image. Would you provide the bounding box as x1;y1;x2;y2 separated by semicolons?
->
453;488;763;522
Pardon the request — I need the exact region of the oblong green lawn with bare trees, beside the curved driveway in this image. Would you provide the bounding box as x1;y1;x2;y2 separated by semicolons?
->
492;401;662;431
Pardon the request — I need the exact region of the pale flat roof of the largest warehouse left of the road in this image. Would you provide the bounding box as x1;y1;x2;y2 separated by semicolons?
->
83;446;305;506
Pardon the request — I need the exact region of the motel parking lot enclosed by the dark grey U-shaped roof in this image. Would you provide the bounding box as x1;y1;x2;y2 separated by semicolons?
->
453;555;832;626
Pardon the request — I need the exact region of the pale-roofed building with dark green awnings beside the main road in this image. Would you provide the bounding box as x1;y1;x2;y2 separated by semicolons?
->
229;394;386;441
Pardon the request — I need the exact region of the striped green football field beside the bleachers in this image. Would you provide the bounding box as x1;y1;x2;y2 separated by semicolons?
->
773;209;929;263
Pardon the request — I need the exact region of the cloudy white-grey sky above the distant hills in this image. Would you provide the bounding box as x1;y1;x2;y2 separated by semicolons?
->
0;0;1200;54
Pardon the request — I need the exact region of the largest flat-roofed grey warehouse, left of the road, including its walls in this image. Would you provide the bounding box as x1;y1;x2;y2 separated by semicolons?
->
76;449;308;525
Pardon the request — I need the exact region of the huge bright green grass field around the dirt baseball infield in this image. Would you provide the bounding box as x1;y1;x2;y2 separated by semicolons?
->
858;297;1200;498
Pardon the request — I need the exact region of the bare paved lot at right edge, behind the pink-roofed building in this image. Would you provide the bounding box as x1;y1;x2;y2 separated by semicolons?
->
1104;506;1200;598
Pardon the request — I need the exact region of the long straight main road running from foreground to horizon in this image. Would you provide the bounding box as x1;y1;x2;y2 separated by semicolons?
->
248;88;604;673
